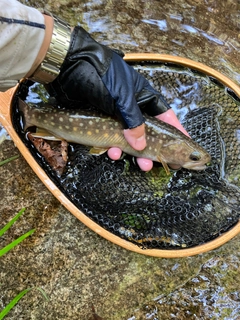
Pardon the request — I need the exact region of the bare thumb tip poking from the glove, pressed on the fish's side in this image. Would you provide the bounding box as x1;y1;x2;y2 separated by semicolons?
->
123;123;147;150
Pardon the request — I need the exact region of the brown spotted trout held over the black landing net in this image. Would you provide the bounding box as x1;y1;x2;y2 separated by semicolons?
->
19;100;211;173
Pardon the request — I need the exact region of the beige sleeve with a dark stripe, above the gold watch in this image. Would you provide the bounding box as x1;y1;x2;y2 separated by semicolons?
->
0;0;45;91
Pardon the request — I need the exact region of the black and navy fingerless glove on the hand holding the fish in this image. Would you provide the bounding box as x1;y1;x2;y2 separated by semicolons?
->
48;27;169;129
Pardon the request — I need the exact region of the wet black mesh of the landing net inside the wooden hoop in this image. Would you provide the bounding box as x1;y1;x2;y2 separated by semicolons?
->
13;62;240;250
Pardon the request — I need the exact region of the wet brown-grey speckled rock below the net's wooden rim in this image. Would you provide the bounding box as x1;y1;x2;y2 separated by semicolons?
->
0;141;240;320
